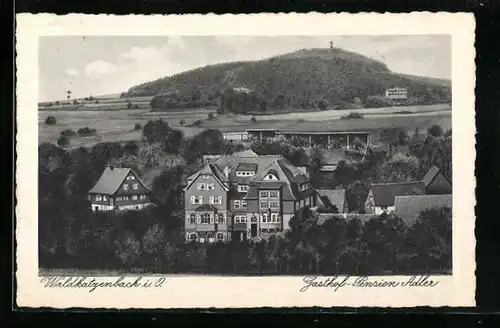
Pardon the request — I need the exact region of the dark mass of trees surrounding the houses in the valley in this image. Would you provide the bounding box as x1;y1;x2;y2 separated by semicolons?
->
38;120;452;275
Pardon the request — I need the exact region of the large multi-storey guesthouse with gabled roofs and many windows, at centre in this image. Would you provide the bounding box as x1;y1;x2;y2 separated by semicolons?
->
184;151;316;242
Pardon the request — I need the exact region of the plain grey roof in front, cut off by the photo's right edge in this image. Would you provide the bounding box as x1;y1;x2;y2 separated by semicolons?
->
394;195;453;225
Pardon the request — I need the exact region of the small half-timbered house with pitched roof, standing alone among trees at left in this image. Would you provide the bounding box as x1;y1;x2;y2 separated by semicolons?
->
88;166;152;212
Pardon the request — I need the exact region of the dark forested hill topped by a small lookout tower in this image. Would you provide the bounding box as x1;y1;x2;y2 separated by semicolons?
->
122;48;451;111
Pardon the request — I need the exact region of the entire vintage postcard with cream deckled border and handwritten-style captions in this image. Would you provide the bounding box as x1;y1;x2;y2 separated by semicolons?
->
15;12;475;309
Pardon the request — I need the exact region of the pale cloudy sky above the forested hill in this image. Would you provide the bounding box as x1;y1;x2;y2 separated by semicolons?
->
39;35;451;101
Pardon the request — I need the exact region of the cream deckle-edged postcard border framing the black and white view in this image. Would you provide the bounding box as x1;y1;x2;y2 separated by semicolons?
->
16;12;476;309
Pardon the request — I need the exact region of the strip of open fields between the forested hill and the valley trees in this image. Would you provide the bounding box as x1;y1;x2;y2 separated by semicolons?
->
38;105;451;148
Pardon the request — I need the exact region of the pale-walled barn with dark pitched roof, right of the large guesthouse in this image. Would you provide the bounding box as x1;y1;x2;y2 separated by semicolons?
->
371;181;425;206
